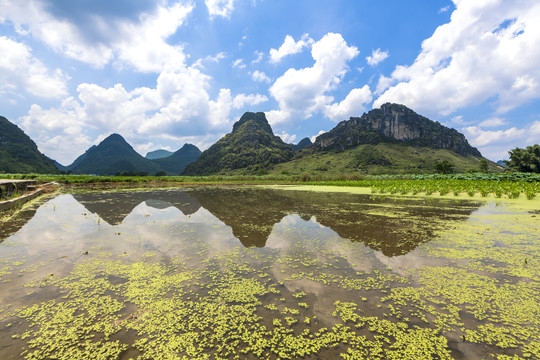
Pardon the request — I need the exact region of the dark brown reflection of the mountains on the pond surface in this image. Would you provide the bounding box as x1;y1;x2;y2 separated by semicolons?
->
69;187;478;256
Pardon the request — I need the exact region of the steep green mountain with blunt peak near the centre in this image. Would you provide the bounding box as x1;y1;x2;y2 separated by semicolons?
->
184;112;293;175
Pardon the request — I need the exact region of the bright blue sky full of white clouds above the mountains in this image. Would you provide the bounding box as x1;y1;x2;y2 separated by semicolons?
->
0;0;540;165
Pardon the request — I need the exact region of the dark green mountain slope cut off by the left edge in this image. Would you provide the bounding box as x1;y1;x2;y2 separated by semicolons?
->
0;116;58;174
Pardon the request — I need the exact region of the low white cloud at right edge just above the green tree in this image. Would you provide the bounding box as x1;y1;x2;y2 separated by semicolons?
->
461;121;540;160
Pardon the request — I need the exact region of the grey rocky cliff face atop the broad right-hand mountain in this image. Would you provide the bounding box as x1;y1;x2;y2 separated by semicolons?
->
313;103;482;156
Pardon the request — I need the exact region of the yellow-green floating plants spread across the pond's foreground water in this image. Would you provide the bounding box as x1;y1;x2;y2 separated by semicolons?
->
0;187;540;359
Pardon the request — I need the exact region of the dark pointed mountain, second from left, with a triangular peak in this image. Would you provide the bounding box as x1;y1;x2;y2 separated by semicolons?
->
68;134;160;175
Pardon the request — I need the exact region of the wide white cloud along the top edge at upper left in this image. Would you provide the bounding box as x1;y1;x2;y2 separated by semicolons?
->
0;0;193;72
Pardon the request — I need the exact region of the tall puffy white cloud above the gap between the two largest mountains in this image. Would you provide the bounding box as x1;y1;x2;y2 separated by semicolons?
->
267;33;366;125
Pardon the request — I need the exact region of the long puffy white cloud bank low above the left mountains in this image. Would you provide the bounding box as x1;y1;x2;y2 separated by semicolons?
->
19;67;268;164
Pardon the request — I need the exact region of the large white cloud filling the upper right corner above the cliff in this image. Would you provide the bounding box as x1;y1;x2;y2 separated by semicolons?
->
374;0;540;115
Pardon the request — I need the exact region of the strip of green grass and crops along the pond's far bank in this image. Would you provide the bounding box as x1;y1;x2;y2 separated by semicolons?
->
0;173;540;199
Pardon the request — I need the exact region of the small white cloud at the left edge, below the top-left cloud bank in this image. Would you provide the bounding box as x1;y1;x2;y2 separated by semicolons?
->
0;36;68;98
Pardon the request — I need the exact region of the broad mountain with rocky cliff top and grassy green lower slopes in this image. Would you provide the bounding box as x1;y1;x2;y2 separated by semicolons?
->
271;103;501;175
